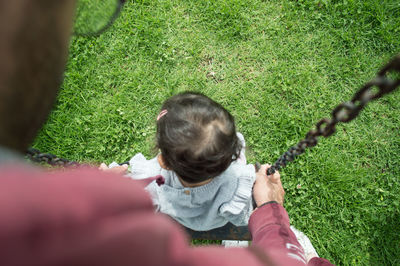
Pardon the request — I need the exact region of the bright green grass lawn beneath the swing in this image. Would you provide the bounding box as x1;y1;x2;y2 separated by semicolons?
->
34;0;400;265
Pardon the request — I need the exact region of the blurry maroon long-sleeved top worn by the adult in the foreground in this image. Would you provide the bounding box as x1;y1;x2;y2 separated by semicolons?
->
0;165;331;266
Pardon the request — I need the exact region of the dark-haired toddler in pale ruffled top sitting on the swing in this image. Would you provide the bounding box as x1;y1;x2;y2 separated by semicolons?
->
110;92;256;231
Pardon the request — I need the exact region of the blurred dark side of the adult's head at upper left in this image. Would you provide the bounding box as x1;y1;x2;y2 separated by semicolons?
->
0;0;75;151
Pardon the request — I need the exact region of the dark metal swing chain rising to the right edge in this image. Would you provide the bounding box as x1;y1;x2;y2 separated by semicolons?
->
267;55;400;175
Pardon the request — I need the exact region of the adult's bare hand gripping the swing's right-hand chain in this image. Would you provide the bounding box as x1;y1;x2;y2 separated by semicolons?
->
253;164;285;207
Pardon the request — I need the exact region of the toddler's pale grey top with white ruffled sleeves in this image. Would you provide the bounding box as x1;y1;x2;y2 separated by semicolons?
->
109;134;256;231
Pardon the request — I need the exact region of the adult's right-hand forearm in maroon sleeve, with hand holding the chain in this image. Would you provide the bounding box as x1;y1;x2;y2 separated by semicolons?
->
249;165;332;265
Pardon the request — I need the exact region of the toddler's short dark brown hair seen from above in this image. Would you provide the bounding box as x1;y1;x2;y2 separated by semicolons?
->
157;92;241;183
